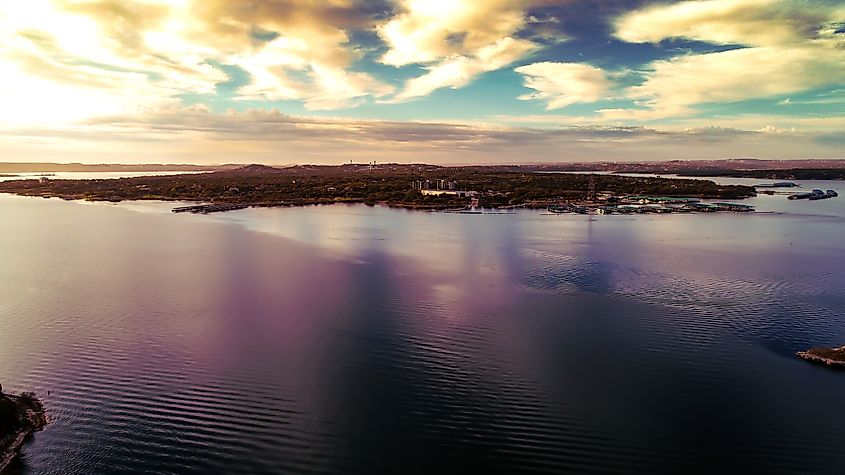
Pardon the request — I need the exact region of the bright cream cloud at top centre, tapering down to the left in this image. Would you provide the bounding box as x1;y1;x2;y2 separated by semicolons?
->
377;0;537;102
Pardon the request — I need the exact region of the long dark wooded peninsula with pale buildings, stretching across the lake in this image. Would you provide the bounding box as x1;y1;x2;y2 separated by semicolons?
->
0;164;755;210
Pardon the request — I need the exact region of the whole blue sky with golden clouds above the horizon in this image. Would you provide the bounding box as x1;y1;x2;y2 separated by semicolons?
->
0;0;845;164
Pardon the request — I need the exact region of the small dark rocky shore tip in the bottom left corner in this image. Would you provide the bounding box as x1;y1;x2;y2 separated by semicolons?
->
0;386;47;473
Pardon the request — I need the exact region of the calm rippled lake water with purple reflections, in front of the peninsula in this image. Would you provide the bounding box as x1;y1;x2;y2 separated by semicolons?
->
0;182;845;474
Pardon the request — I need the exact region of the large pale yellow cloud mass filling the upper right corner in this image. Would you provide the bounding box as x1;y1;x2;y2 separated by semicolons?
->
604;0;845;120
